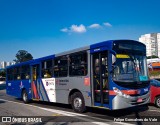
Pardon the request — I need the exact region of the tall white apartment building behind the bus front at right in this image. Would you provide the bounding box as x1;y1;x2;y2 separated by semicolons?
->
139;33;160;57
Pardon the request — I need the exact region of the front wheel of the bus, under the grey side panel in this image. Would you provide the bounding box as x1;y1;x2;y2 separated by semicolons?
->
71;92;86;113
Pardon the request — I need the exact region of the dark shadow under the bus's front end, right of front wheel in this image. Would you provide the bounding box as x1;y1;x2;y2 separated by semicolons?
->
88;105;149;125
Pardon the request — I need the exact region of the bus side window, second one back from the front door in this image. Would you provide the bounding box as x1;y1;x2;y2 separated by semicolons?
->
54;56;68;77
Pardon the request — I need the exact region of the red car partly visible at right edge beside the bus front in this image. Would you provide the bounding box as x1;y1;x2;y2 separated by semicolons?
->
150;79;160;108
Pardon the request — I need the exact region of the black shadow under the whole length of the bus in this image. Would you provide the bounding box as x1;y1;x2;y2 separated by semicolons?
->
17;98;149;118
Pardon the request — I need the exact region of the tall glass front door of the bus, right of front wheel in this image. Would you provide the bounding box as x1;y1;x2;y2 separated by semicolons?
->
91;51;109;107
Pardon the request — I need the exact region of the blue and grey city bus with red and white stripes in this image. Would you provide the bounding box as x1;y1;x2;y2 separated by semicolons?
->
6;40;150;112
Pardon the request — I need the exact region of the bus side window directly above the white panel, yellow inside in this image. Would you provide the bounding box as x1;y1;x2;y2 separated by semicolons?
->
41;60;52;78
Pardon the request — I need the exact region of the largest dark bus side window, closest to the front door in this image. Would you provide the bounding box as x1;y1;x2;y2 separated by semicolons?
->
69;52;87;76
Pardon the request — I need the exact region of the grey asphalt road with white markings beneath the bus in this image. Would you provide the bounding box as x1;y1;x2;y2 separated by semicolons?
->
0;84;160;125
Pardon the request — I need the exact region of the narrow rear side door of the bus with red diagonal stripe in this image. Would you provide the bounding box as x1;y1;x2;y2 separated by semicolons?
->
31;64;40;99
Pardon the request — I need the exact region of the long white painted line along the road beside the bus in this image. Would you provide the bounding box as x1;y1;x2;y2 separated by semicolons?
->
0;99;133;125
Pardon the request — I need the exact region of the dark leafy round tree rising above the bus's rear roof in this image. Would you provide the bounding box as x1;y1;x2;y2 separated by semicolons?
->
13;50;33;63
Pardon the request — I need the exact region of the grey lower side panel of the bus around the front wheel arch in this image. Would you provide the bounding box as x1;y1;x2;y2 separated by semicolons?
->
55;76;91;106
